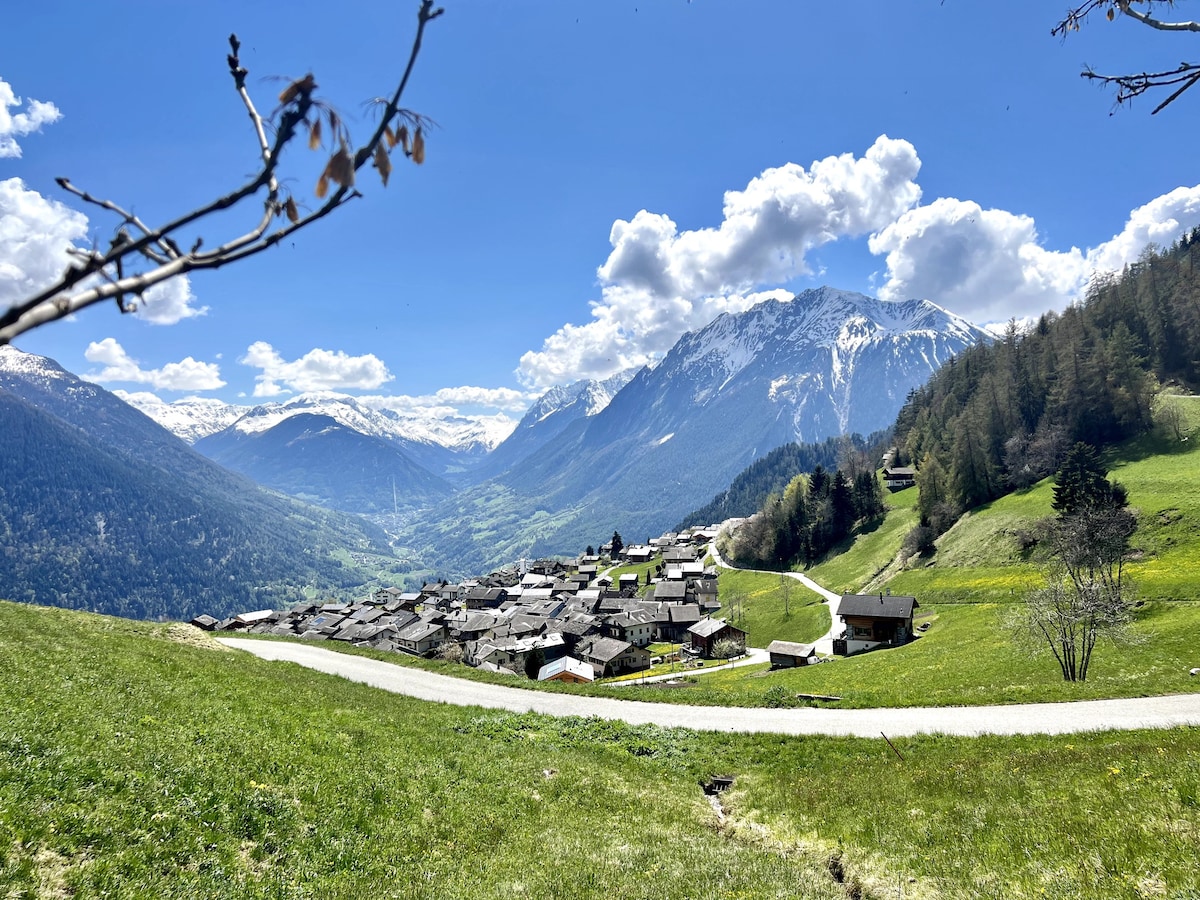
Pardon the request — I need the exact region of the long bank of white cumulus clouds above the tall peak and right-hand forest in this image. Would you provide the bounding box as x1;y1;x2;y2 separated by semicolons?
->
517;134;1200;388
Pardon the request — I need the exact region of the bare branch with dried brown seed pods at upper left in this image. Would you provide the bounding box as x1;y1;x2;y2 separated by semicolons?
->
0;0;443;344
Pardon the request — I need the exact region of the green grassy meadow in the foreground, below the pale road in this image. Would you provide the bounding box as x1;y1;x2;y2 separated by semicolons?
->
0;604;1200;899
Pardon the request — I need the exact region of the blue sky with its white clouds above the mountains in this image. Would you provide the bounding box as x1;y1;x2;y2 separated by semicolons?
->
0;0;1200;427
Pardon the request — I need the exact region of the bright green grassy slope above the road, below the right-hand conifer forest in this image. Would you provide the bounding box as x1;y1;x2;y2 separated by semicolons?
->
637;397;1200;707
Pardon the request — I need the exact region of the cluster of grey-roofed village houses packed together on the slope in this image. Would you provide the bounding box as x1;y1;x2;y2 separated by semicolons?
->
192;529;745;682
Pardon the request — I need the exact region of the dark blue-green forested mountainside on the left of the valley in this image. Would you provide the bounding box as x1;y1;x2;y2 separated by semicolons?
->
0;347;390;619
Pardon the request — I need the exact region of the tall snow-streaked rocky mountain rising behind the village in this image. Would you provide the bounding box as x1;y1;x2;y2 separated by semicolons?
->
400;288;991;571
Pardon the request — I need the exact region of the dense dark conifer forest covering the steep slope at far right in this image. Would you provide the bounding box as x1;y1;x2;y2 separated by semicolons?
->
895;229;1200;533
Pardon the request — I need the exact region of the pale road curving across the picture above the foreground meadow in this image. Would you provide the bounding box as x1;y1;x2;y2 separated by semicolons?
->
217;637;1200;738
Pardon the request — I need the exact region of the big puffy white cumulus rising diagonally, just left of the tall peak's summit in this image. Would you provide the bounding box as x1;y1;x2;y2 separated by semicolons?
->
517;136;920;388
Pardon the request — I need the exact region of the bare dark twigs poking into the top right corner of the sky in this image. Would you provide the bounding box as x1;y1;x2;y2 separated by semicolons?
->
1050;0;1200;115
